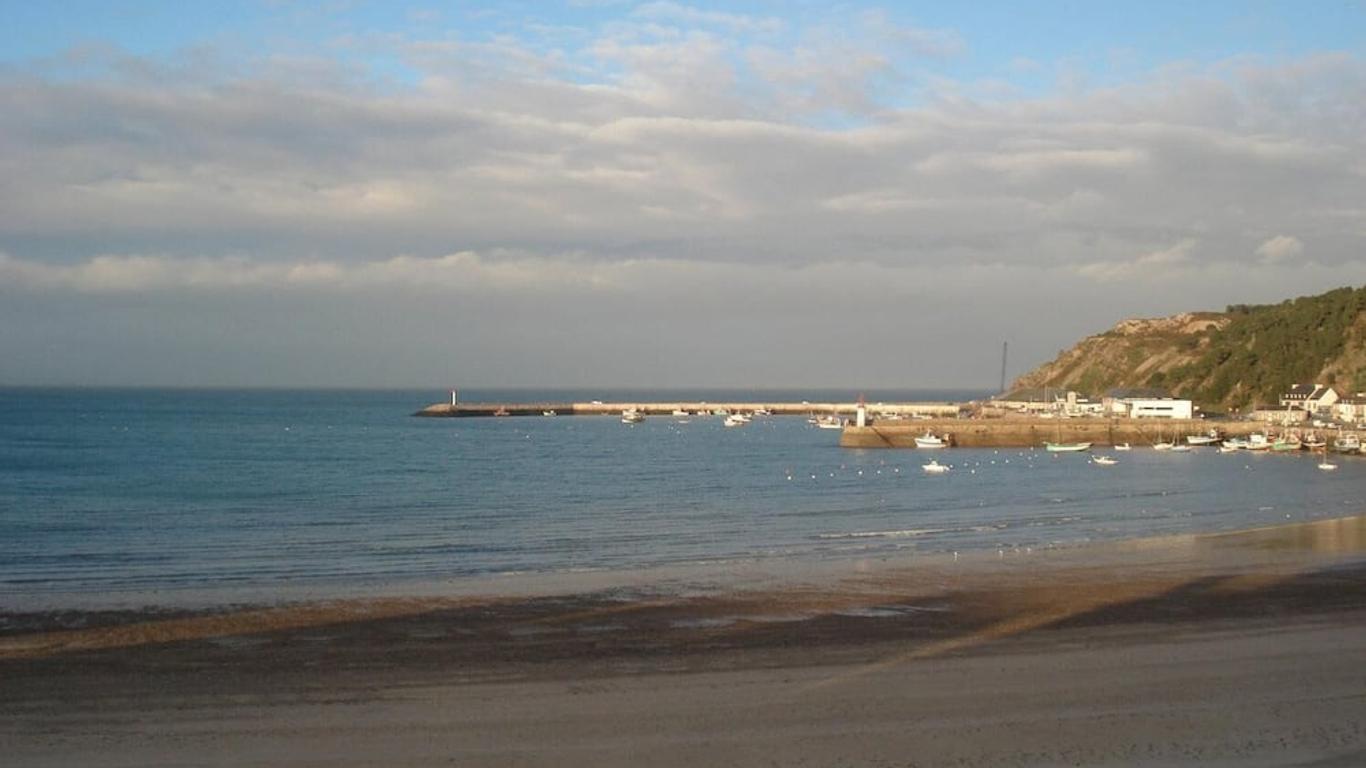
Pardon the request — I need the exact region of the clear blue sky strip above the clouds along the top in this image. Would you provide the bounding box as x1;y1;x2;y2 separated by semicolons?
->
10;0;1366;96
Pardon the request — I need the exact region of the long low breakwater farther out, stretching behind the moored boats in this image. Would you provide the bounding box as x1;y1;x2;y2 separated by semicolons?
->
413;400;959;415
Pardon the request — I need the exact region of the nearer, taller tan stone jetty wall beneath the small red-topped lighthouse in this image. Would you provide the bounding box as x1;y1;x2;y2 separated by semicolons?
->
840;418;1266;448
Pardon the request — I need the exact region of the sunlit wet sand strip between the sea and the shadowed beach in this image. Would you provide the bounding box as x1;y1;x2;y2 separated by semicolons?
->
0;514;1366;663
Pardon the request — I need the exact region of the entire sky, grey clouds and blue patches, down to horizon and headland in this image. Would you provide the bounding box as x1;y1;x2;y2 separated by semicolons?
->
0;0;1366;391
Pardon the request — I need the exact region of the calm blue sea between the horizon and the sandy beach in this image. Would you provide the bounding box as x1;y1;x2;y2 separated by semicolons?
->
0;388;1366;609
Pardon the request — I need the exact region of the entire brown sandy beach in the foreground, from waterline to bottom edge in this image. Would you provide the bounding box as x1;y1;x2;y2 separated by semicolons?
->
0;518;1366;765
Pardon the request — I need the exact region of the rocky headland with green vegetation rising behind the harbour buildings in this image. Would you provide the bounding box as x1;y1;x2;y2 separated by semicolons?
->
1015;288;1366;409
